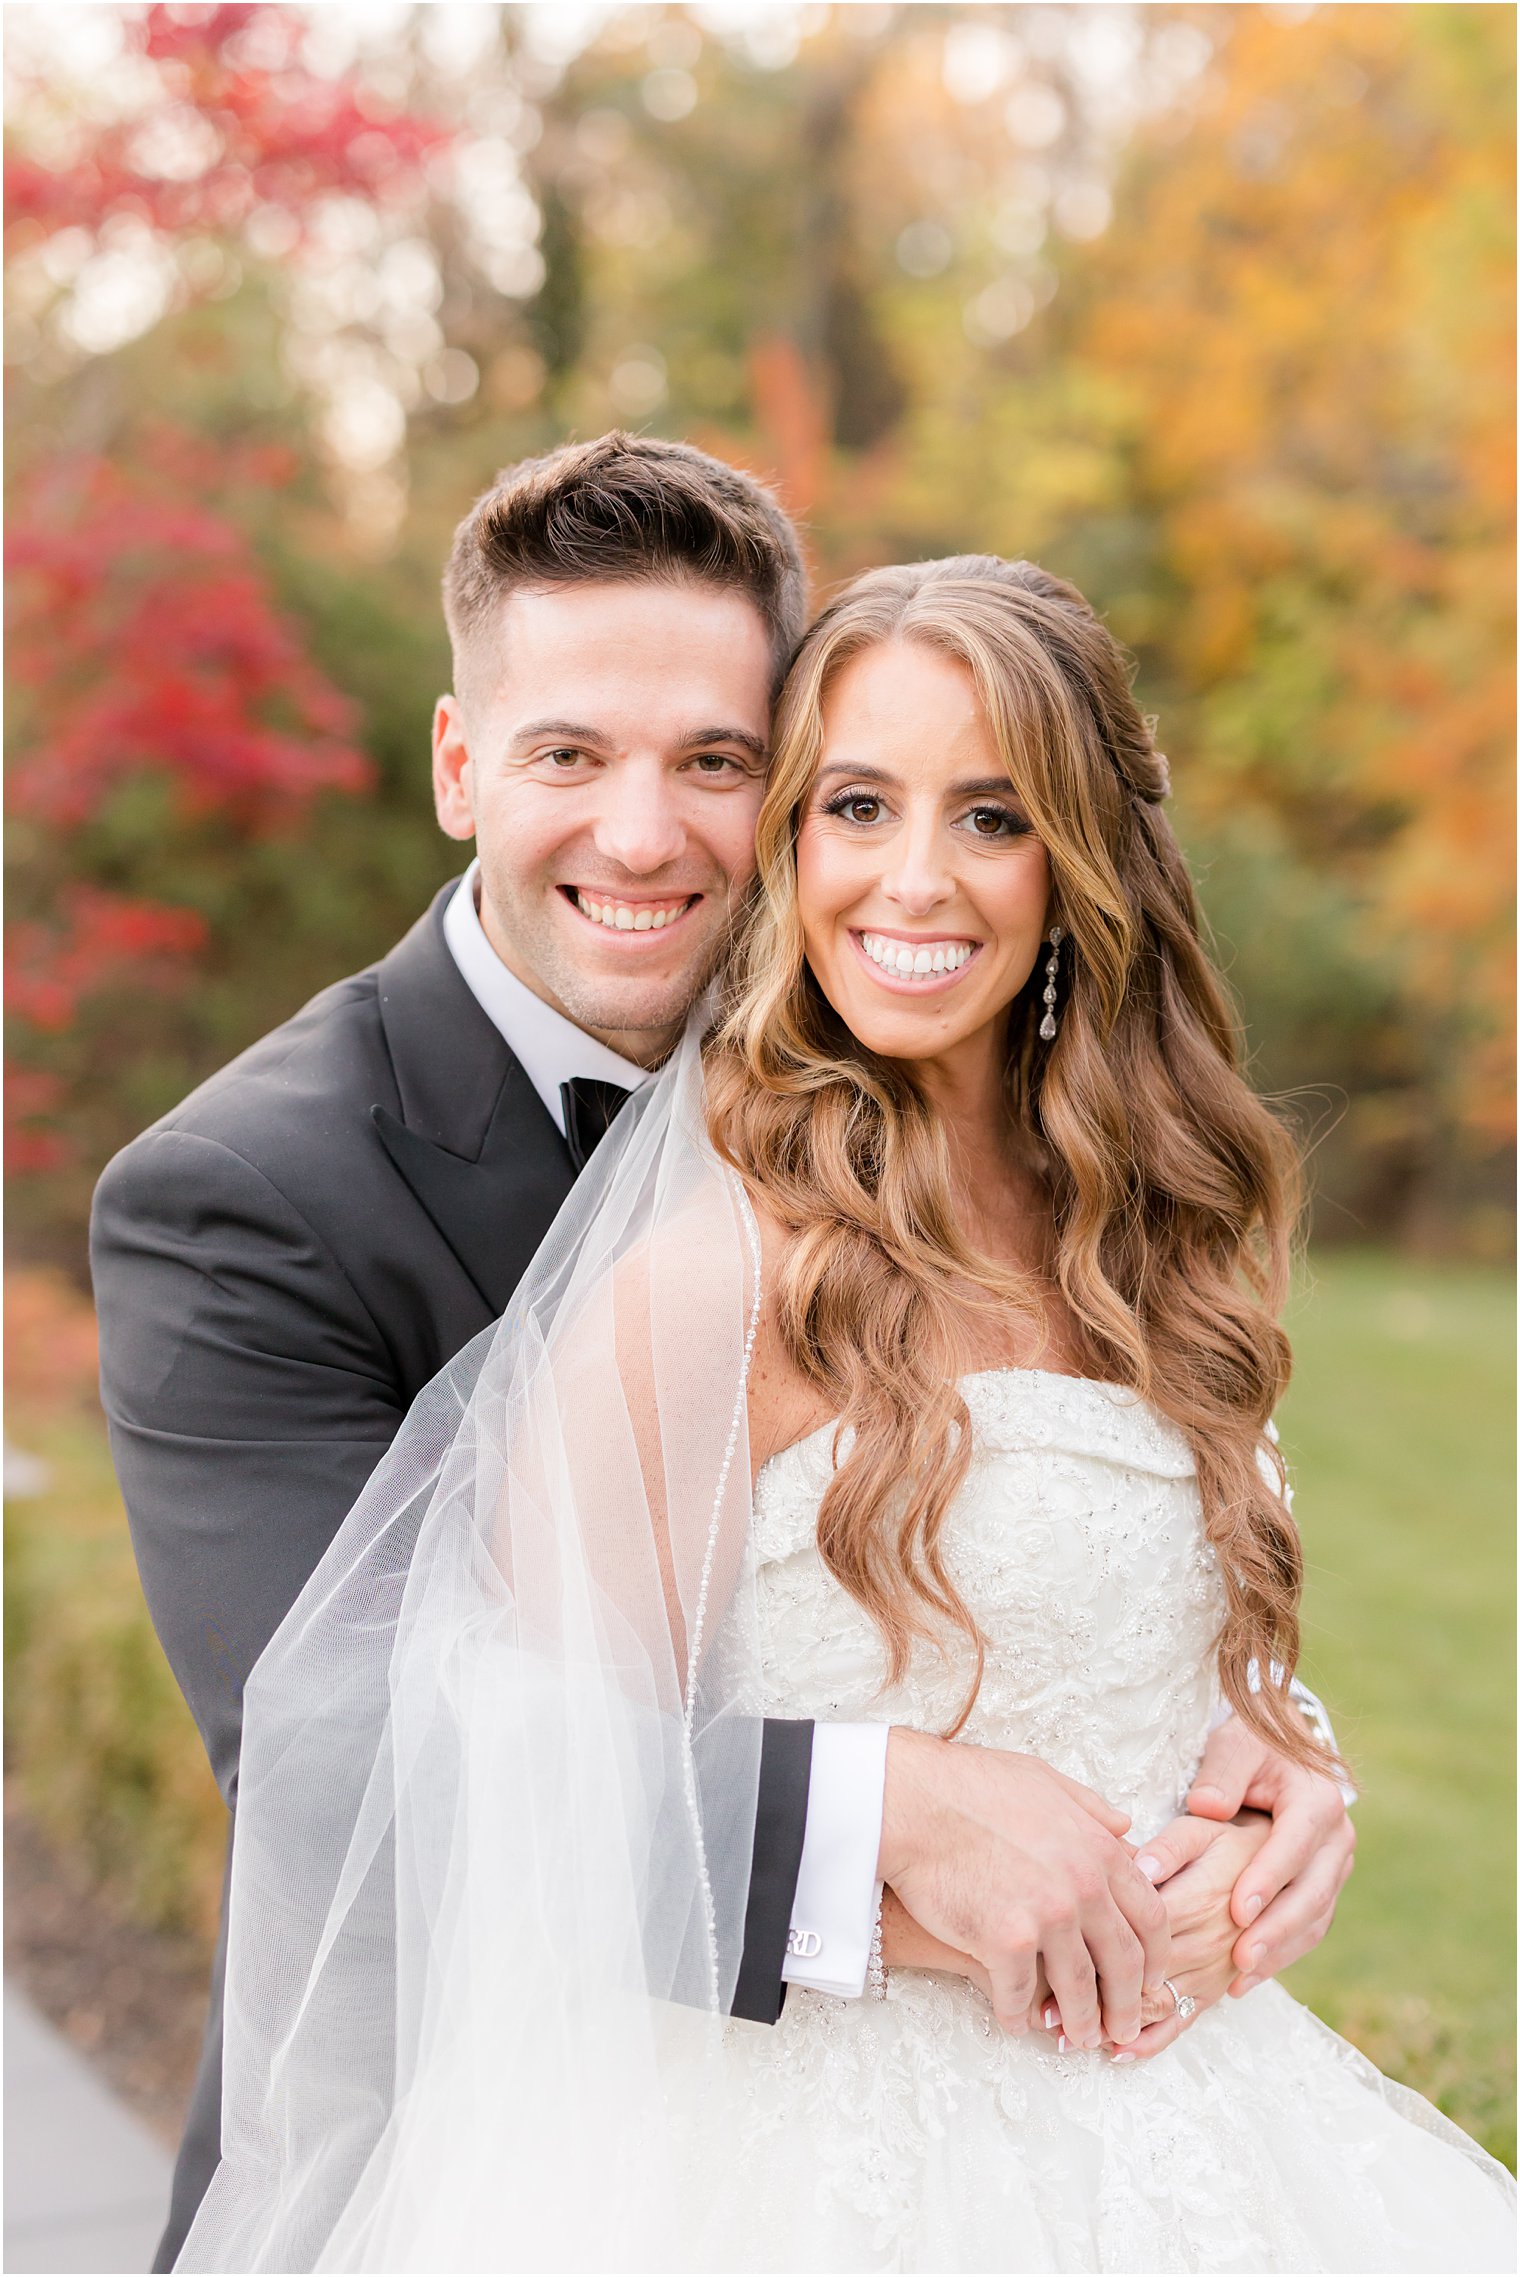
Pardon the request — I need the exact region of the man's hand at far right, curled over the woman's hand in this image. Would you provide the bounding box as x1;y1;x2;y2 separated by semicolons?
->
1174;1717;1356;1999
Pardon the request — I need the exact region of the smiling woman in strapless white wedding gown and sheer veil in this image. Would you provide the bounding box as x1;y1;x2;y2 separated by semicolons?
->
180;558;1513;2270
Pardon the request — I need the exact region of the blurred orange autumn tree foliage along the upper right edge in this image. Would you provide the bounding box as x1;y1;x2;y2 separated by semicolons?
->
1074;7;1515;1152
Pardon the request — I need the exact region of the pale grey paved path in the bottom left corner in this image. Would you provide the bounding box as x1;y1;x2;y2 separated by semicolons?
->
5;1983;171;2277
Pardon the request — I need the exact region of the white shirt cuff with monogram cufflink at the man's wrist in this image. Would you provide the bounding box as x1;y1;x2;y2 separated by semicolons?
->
780;1724;892;1999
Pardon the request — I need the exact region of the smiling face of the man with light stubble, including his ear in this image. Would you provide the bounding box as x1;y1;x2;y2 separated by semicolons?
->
432;583;771;1066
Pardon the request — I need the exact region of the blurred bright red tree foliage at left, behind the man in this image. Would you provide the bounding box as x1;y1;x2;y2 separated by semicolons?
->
5;5;441;1175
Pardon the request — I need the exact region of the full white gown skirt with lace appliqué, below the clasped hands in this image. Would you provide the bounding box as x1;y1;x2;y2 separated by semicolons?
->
687;1972;1515;2277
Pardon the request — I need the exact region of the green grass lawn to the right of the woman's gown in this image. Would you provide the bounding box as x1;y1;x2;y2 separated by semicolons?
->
1281;1252;1515;2165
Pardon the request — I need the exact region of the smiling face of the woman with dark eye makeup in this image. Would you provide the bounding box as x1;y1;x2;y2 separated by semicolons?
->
796;640;1049;1066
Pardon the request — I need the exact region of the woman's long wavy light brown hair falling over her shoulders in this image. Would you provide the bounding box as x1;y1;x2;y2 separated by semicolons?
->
705;556;1324;1767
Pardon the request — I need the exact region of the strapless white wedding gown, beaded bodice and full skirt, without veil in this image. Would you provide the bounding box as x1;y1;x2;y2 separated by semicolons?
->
671;1371;1515;2272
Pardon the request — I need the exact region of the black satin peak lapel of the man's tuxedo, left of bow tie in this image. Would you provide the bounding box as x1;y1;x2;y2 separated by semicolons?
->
371;886;576;1318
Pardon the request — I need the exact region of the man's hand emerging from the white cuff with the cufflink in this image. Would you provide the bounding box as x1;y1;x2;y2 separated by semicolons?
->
878;1728;1172;2047
